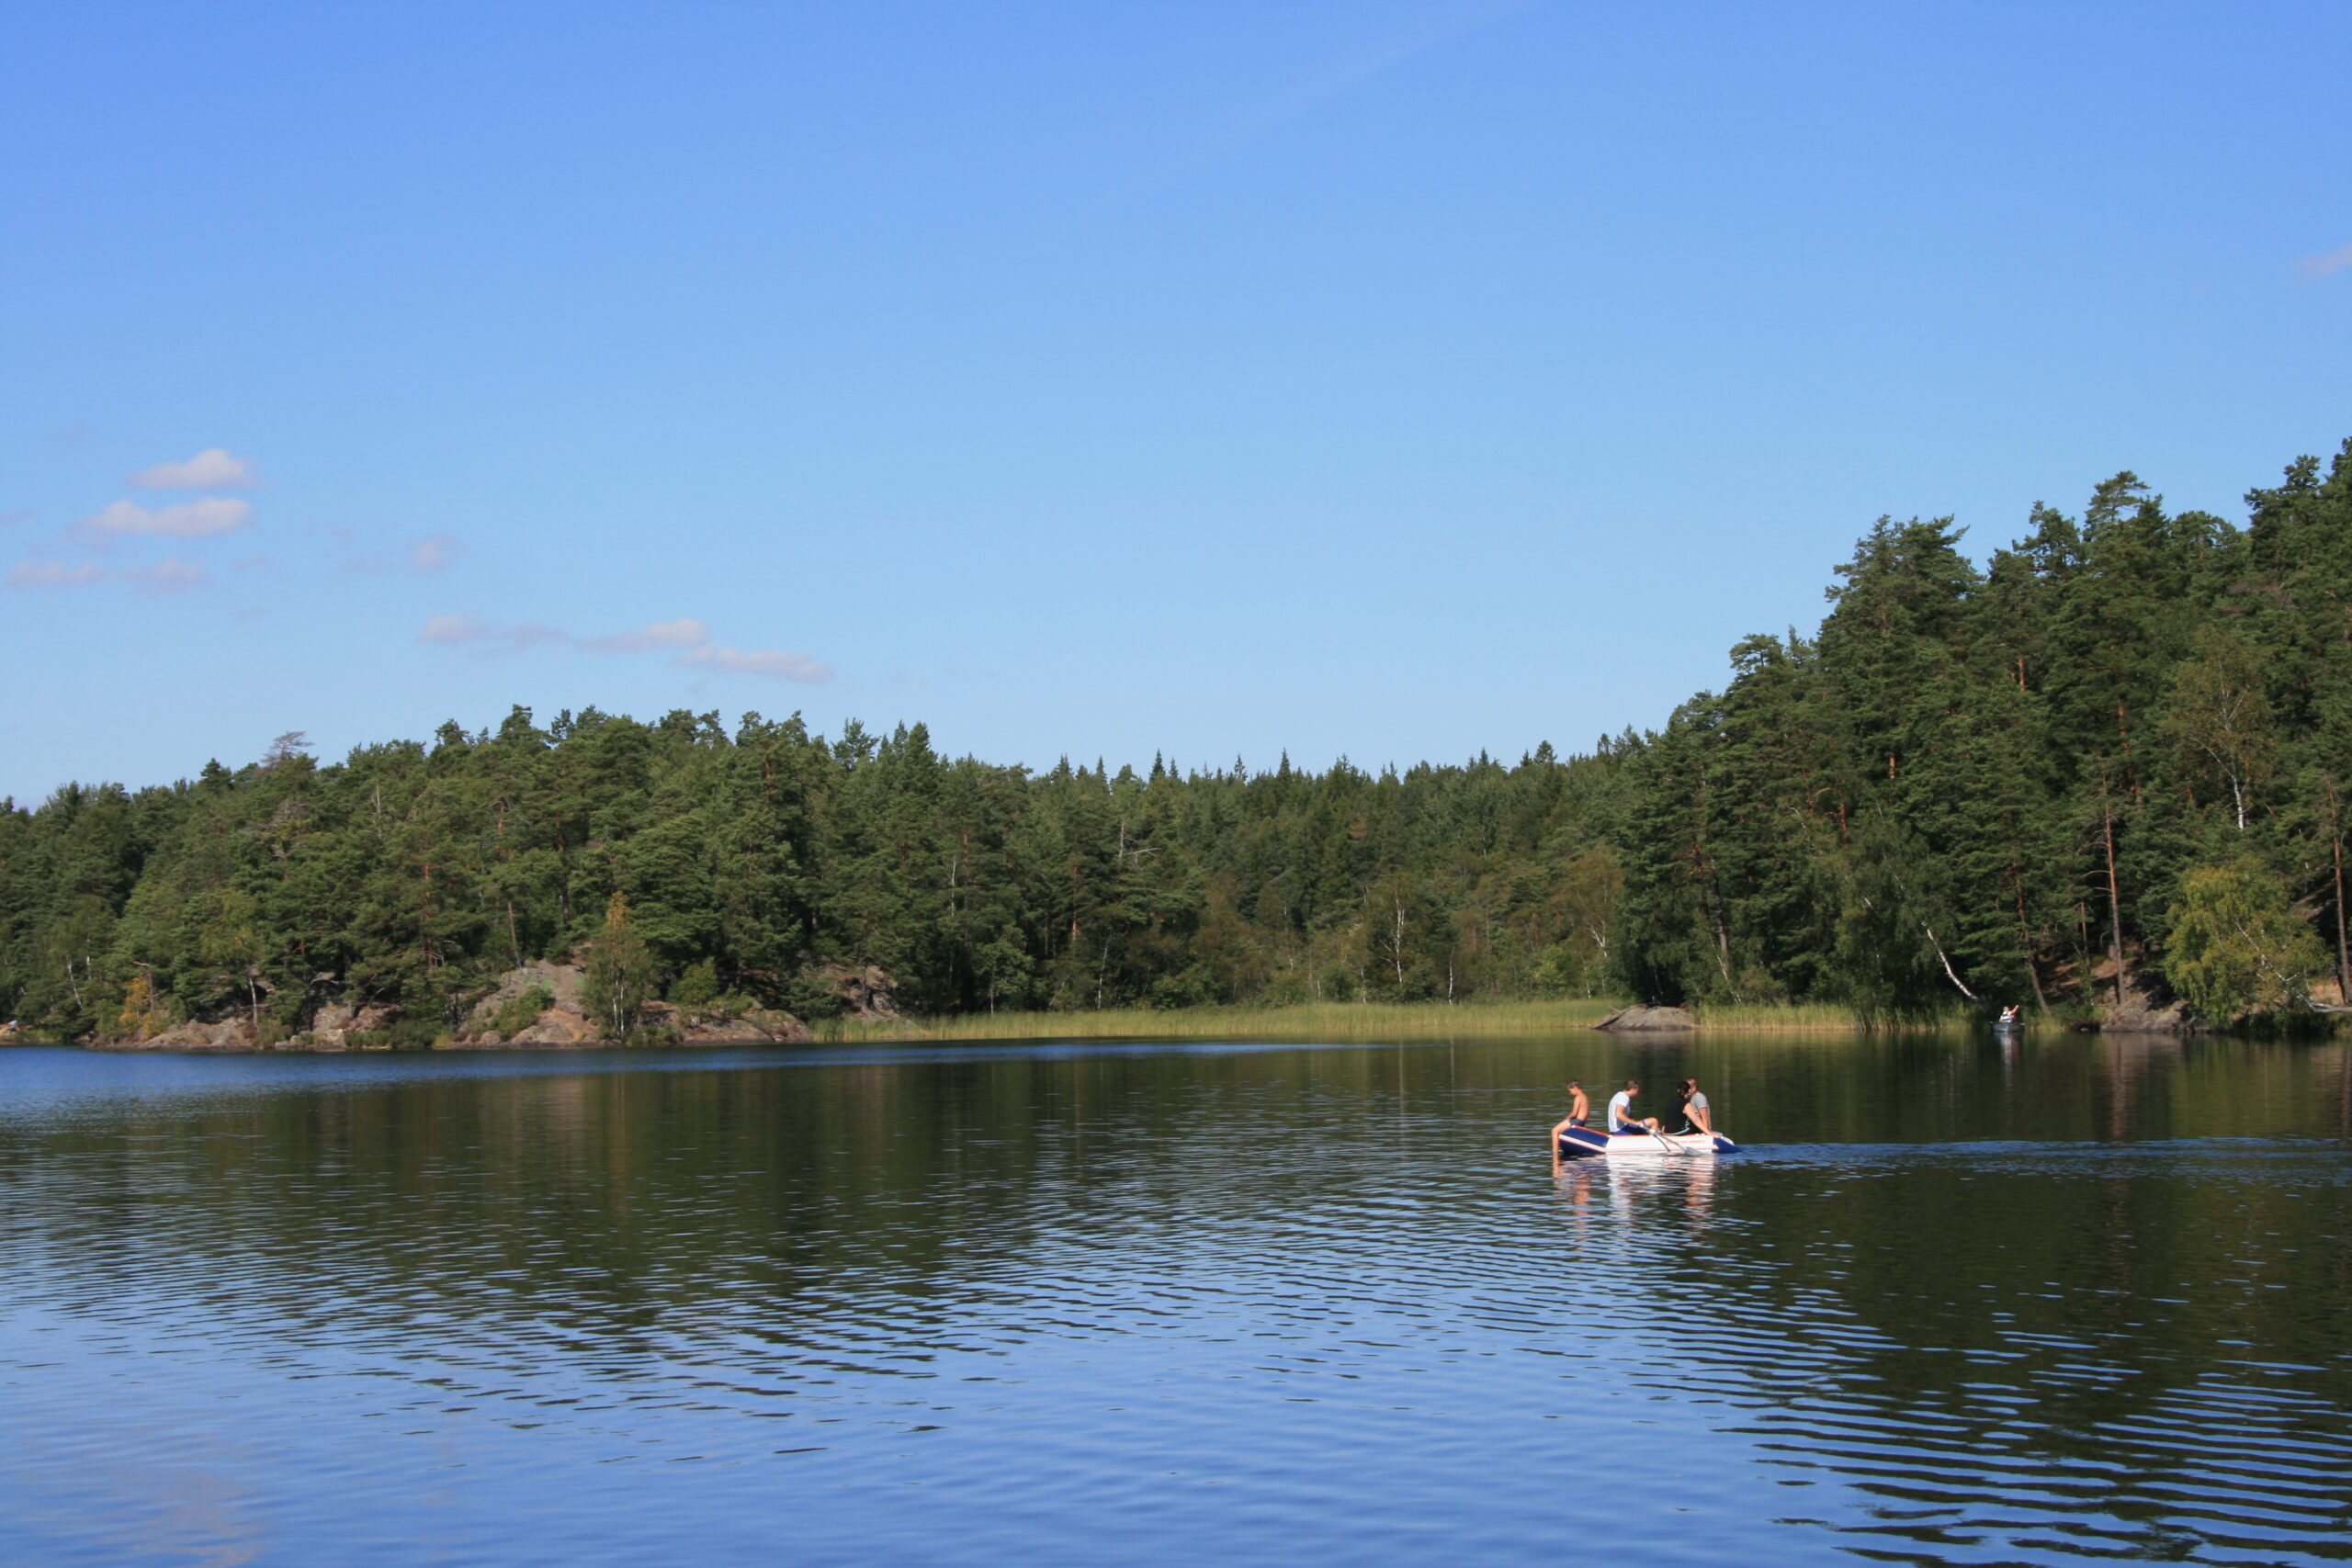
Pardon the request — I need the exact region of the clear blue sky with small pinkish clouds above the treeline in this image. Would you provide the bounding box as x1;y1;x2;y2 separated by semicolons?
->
0;0;2352;802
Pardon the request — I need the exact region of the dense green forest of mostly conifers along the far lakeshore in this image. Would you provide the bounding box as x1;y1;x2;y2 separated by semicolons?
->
0;442;2352;1037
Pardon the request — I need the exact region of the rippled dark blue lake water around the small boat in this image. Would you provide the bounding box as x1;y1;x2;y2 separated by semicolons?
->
0;1034;2352;1568
